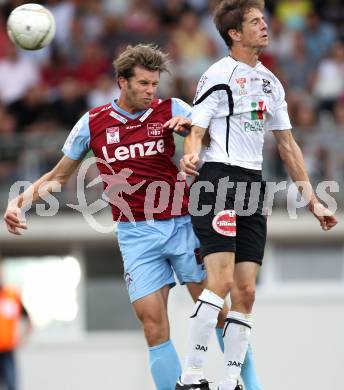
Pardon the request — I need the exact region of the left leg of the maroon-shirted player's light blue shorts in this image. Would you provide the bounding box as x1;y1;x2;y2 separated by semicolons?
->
117;224;175;303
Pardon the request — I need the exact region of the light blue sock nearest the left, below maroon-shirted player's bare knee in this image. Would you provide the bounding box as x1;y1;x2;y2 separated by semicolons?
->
149;340;182;390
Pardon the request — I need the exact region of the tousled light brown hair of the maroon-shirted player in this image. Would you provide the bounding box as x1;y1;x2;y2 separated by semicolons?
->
113;44;169;79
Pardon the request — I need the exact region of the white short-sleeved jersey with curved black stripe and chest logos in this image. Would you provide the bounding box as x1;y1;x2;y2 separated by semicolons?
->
192;56;291;170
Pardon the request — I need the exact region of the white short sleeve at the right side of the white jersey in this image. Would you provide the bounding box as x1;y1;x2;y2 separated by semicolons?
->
265;79;292;130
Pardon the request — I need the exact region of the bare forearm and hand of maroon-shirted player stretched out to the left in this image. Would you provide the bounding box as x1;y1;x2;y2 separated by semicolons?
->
4;156;82;235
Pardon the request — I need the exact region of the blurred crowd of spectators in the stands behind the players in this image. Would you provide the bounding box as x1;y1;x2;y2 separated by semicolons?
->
0;0;344;206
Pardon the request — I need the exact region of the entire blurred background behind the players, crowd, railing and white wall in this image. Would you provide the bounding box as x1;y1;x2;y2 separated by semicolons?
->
0;0;344;390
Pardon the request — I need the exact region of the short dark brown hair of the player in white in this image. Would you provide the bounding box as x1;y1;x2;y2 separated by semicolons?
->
214;0;265;48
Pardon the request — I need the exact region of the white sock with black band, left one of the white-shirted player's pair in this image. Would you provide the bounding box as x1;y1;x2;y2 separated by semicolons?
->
181;289;224;384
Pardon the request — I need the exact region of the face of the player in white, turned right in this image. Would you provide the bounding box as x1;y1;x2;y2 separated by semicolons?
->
240;8;269;49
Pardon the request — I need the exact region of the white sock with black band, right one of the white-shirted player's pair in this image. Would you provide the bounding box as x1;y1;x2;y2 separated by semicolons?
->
219;311;252;390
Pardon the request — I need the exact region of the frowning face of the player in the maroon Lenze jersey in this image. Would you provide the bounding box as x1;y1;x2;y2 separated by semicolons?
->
122;66;160;111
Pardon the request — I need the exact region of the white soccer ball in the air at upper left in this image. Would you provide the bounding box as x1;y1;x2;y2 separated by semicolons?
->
7;3;56;50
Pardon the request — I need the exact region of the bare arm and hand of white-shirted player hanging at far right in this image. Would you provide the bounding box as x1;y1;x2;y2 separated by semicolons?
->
273;130;338;230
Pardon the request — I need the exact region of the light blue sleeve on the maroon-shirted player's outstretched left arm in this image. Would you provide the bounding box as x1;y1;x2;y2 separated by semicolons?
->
62;112;90;160
